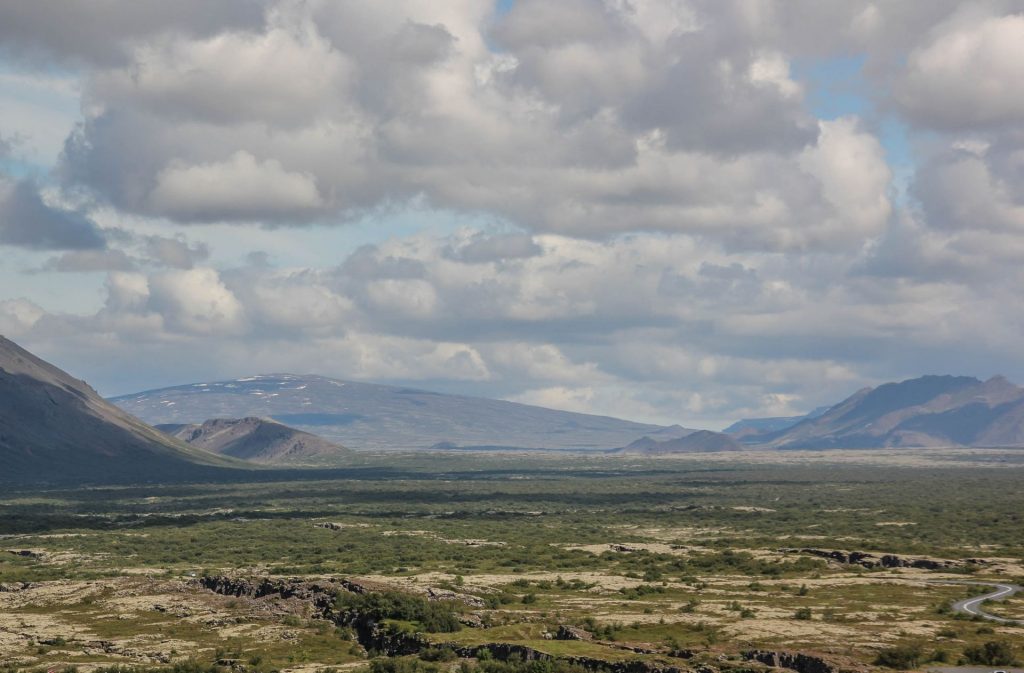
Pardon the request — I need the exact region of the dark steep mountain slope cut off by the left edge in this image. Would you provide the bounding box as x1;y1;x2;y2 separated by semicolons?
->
0;337;234;482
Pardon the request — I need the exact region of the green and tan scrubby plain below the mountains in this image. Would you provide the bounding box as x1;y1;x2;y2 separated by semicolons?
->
0;450;1024;673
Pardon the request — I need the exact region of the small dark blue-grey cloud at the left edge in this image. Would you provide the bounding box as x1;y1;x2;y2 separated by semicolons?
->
0;178;105;250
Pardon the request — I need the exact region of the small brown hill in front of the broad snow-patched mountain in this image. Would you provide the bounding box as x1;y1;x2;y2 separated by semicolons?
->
157;418;348;464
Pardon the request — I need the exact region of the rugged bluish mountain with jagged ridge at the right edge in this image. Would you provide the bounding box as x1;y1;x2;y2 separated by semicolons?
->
758;376;1024;449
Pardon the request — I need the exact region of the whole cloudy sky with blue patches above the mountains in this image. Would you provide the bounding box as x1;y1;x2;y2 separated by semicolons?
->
0;0;1024;428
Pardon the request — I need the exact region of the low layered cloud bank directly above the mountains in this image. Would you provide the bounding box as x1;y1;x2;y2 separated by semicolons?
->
12;222;1024;427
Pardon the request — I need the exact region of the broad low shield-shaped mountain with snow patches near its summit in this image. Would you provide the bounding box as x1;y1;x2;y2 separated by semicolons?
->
112;374;686;450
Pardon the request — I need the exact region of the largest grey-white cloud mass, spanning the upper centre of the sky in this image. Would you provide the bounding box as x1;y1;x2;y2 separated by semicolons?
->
29;0;886;254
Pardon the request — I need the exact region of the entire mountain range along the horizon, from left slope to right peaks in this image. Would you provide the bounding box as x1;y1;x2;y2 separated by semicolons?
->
0;337;1024;482
